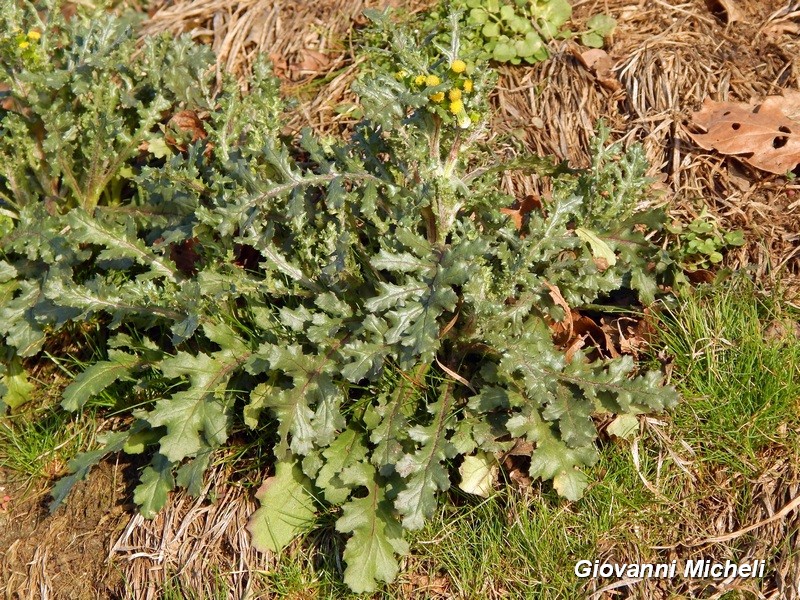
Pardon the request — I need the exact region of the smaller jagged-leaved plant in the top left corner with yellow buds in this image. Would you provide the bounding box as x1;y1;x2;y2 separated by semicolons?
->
0;1;213;214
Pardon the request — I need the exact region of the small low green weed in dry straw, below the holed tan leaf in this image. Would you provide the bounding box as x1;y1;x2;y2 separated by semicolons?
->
667;208;745;271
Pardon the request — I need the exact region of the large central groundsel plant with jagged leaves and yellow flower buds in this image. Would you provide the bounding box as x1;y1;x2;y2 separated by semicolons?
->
0;7;675;591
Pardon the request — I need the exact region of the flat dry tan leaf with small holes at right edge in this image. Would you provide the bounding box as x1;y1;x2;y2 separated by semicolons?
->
689;93;800;175
